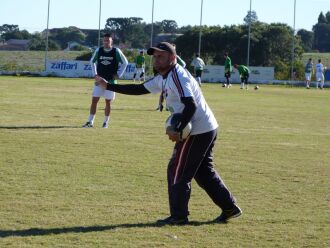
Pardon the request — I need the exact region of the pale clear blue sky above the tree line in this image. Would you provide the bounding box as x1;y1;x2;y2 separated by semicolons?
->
0;0;330;32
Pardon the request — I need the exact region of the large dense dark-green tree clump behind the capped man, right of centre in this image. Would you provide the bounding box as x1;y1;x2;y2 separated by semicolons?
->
175;22;303;79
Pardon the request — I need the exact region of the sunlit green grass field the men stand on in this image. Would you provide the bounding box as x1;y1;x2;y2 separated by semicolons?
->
0;76;330;248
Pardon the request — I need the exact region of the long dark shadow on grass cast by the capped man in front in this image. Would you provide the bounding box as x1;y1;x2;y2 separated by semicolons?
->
0;221;219;238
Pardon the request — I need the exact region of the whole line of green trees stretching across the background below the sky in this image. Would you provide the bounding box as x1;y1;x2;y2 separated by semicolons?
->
0;11;330;78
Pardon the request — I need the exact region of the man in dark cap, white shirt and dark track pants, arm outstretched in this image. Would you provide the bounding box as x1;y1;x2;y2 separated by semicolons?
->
98;42;242;225
